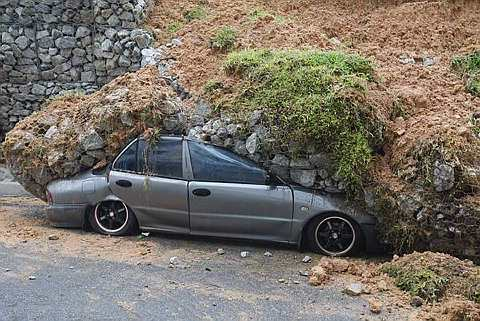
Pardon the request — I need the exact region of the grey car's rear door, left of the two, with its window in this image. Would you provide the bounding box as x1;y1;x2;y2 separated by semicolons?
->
111;137;190;233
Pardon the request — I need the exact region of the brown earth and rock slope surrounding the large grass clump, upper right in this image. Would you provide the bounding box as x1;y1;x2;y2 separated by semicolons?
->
147;0;480;259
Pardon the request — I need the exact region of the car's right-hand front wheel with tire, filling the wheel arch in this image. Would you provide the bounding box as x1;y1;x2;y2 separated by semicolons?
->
306;213;363;256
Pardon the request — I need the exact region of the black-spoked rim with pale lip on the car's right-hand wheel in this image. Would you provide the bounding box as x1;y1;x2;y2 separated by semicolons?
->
315;216;356;256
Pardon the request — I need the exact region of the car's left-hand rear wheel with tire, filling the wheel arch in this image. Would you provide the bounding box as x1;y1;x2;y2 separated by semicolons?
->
88;200;138;236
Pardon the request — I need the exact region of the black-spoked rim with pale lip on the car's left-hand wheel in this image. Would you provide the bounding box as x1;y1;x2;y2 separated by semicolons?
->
95;201;129;233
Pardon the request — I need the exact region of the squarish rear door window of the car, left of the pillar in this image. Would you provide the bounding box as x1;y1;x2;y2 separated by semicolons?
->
144;138;183;178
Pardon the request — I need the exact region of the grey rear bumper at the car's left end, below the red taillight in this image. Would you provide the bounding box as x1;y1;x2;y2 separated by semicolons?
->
47;204;87;228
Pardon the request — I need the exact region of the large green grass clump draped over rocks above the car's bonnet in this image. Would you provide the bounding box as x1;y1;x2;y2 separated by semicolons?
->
223;50;383;191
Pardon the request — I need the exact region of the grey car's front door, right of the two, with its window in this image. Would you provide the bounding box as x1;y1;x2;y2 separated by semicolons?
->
188;141;293;241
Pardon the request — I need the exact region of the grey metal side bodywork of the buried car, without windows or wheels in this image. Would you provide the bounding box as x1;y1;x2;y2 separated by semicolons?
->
47;134;378;249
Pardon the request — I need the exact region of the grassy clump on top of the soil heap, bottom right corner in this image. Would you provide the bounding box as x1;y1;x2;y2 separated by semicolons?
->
381;252;480;303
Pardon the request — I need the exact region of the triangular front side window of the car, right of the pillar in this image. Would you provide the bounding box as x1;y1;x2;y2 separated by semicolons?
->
188;142;267;185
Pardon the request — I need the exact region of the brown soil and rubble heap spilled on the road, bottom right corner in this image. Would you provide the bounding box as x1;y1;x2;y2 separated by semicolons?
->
309;252;480;321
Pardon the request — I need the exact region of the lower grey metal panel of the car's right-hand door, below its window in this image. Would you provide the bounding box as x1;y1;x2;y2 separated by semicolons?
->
189;181;293;242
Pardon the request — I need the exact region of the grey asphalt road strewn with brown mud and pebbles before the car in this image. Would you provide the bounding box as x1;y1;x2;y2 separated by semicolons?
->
0;191;407;321
